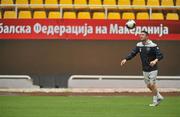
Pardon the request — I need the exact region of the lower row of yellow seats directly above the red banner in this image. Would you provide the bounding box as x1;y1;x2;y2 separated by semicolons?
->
0;11;179;20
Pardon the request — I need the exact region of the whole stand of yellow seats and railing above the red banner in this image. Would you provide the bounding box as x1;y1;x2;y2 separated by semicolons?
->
0;0;180;20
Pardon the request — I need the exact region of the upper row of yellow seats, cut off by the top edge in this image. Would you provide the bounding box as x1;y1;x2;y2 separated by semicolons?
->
1;0;180;8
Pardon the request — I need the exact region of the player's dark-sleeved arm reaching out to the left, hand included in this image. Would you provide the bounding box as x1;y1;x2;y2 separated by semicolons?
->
121;46;139;66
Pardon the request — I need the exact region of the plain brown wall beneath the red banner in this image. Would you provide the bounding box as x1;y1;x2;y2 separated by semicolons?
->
0;40;180;87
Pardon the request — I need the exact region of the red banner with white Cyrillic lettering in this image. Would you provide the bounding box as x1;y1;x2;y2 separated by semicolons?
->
0;19;180;40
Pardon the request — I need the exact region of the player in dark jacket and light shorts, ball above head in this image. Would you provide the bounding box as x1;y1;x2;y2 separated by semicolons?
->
121;31;164;106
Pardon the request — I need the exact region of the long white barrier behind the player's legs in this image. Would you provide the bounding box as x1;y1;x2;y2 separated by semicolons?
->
68;75;180;88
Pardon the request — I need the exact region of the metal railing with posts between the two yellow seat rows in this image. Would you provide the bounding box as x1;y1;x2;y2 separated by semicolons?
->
0;4;180;19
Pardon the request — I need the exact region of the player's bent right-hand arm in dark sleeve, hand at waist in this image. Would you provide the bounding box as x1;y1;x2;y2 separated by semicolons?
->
150;46;163;66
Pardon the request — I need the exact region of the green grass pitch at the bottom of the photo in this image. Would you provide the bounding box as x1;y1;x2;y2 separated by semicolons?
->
0;96;180;117
